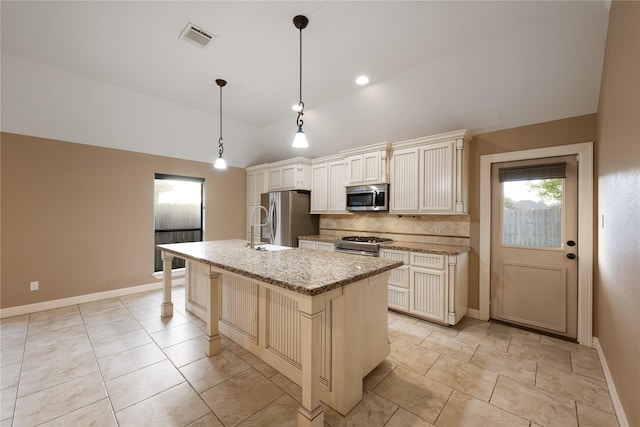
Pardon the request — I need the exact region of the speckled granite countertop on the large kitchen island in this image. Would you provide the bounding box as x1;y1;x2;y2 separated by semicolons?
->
157;239;402;296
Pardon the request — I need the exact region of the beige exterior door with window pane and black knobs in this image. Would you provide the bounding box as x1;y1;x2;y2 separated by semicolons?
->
491;156;578;338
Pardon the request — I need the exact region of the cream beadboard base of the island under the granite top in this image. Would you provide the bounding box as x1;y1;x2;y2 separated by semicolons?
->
200;268;390;420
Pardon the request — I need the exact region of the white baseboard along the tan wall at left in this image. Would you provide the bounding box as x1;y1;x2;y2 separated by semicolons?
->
0;277;185;319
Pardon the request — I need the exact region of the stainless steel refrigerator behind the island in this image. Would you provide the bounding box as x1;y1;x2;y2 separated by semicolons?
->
260;190;319;247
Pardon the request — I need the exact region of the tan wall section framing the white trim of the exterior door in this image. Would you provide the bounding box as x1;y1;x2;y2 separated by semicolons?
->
469;114;597;309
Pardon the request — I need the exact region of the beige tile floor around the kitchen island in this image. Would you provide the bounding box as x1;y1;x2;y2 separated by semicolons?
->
0;288;618;427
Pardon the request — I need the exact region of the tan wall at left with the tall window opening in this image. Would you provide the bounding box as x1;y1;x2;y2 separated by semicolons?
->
0;133;246;308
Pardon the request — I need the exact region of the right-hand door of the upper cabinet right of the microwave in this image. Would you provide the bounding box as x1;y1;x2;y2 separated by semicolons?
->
420;141;455;213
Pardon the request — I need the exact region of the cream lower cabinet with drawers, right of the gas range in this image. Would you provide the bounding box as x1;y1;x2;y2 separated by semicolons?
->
380;248;468;325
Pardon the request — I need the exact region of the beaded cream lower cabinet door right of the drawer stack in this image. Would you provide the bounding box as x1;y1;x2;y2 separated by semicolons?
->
409;267;449;323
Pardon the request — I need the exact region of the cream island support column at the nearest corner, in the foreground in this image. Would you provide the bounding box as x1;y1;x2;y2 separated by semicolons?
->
298;295;325;427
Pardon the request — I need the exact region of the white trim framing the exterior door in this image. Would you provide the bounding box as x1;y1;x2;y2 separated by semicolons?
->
478;142;593;347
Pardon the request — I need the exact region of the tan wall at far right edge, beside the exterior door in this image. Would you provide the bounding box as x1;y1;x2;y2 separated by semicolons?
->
594;1;640;426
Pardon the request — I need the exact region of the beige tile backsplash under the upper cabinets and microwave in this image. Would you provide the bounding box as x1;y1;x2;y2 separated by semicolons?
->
320;212;470;246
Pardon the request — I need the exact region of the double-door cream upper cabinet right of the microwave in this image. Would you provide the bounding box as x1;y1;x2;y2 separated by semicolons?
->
389;130;470;214
